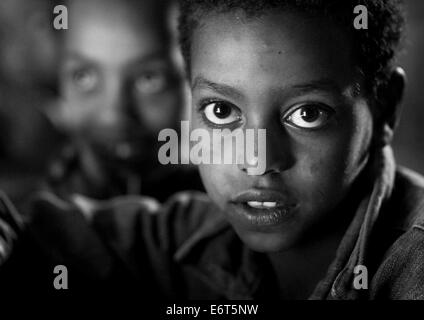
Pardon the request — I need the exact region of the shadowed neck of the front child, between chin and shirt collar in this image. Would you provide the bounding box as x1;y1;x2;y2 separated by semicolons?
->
268;168;372;299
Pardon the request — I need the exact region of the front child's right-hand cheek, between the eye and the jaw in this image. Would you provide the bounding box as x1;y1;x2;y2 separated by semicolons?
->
291;108;372;212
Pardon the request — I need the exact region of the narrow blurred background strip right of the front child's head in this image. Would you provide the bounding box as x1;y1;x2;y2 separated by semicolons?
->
394;0;424;174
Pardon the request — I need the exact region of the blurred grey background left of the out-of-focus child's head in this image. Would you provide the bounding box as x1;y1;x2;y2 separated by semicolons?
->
0;0;59;204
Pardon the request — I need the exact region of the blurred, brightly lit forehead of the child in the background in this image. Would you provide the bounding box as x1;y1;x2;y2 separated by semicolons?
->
64;0;170;61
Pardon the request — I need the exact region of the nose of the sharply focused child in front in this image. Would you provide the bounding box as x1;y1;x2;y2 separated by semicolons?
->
239;117;294;175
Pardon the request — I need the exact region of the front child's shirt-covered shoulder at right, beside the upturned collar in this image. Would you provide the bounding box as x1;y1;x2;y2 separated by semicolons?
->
371;168;424;300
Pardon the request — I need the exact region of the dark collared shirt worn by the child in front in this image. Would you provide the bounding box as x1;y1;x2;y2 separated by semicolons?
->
0;148;424;300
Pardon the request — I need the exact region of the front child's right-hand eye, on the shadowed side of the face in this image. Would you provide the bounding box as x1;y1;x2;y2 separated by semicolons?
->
284;104;334;129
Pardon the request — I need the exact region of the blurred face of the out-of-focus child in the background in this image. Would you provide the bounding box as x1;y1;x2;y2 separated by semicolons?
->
61;0;184;167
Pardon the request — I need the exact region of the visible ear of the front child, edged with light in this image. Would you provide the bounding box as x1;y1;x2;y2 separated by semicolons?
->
374;67;406;147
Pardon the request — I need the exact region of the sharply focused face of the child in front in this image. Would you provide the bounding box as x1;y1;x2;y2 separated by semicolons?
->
191;13;373;251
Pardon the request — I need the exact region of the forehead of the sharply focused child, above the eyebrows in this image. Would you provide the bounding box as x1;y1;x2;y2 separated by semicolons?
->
191;12;354;89
